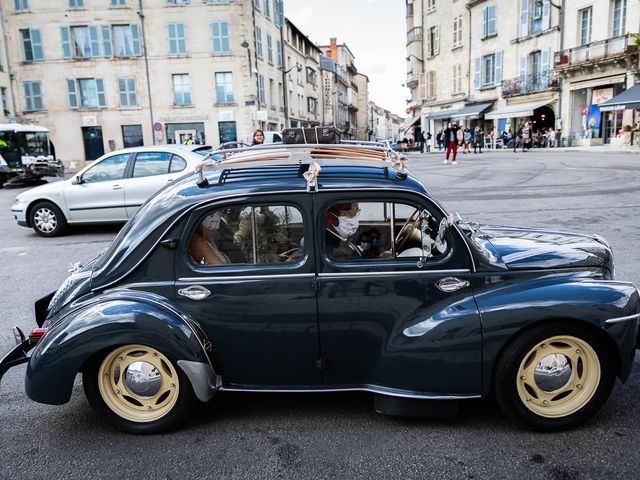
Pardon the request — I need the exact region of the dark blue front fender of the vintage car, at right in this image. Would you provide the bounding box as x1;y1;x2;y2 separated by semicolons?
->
474;274;640;394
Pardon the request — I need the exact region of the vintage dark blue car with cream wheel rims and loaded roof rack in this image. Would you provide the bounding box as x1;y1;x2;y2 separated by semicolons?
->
0;143;640;433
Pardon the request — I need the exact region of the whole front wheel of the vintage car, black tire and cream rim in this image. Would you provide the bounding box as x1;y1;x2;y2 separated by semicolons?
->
494;322;617;432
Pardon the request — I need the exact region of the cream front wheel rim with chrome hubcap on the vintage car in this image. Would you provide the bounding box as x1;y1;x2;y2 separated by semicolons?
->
516;335;601;418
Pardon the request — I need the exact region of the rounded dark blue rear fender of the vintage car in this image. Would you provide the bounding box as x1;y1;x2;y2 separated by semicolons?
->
25;290;220;405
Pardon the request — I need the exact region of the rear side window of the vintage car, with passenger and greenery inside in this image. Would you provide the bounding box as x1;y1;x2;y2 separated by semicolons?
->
189;205;304;266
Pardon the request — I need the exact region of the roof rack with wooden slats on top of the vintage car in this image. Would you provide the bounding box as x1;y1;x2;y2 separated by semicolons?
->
194;140;408;192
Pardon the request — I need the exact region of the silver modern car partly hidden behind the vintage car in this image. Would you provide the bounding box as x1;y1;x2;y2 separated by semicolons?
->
11;145;211;237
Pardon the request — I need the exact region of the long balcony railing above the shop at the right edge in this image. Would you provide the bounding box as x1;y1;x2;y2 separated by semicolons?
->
553;35;637;70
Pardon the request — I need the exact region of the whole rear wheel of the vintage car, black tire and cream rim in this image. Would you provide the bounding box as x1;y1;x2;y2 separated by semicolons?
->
82;345;197;433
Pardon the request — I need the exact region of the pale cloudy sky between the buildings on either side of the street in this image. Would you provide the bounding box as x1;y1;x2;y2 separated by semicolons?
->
284;0;409;117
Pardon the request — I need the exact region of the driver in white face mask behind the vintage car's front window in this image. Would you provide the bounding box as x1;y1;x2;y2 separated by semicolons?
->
324;203;363;258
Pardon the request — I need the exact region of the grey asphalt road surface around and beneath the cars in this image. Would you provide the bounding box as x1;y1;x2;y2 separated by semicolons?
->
0;152;640;480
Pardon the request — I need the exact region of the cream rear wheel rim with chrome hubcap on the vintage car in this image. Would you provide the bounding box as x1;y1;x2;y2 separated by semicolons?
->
98;345;180;422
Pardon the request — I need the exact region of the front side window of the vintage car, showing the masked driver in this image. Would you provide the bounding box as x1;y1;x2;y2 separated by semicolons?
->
324;201;450;262
